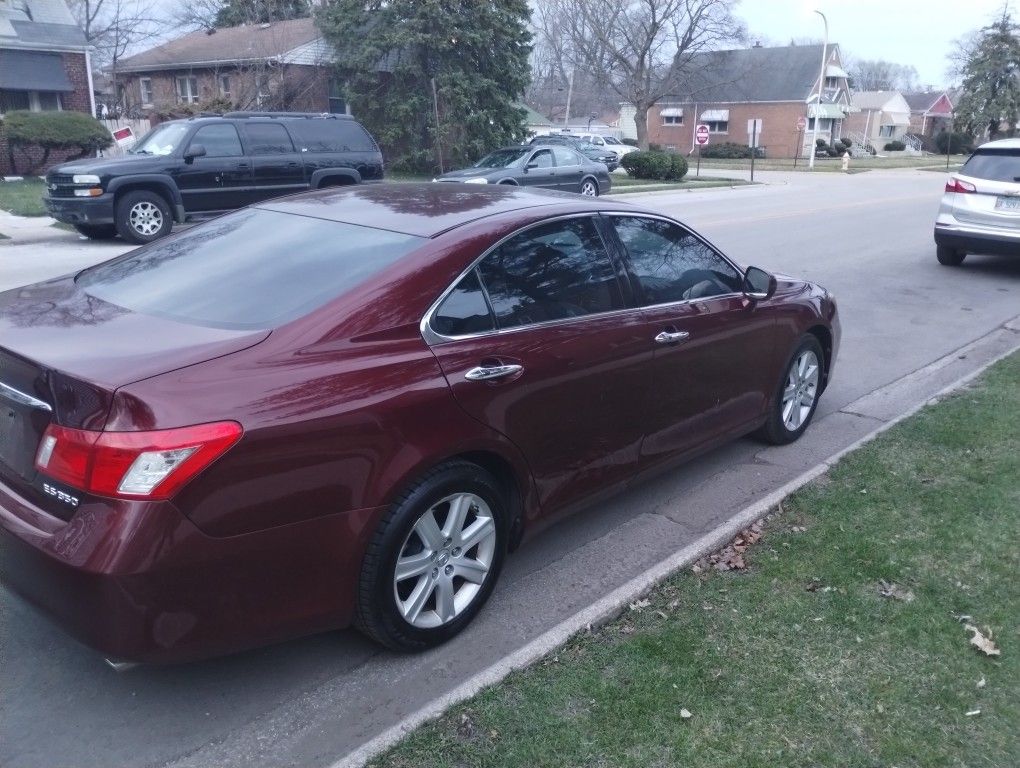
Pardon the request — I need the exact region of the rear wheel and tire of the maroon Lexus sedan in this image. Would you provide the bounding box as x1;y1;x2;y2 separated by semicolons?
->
355;461;509;652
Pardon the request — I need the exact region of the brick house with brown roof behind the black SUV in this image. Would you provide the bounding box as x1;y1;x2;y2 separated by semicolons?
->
116;18;347;113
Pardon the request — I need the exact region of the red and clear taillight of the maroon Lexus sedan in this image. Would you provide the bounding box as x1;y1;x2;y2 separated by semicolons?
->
36;421;242;500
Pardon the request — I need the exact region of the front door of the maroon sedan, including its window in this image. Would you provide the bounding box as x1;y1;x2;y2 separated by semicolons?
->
608;214;775;461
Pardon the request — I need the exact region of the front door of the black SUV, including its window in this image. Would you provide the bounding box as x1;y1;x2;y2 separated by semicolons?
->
176;122;252;213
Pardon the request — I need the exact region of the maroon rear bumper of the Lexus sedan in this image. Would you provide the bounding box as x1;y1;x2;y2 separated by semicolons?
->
0;483;383;662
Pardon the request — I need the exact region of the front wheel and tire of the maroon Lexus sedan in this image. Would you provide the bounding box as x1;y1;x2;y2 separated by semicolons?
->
758;334;825;446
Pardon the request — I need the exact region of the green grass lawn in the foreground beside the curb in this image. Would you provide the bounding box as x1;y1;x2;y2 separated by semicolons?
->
372;355;1020;768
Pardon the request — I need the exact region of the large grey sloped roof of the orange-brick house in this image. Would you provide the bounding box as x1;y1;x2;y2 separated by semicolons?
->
677;43;838;103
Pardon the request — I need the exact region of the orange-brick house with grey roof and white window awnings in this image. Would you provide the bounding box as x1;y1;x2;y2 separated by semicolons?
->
620;43;854;157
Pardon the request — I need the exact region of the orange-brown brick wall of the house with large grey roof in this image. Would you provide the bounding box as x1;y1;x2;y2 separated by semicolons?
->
648;102;829;157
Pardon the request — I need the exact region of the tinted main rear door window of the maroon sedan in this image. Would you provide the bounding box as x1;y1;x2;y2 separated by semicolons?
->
478;217;623;328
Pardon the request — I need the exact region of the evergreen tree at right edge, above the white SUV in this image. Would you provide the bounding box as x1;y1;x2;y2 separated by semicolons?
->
956;10;1020;138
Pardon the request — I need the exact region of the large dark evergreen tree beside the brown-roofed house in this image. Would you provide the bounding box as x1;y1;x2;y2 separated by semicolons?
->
318;0;531;172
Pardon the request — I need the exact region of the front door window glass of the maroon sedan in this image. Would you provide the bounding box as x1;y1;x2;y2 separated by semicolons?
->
610;216;742;306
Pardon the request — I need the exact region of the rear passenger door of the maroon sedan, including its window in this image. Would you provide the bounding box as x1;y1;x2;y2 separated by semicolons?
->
428;216;654;510
